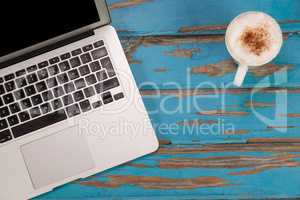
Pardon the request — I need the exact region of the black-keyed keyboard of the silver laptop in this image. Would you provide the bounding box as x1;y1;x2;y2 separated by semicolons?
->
0;40;124;143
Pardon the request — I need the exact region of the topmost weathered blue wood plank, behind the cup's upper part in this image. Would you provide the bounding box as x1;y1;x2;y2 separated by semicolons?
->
108;0;300;35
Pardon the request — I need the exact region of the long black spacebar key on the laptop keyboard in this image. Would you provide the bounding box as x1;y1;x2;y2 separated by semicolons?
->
11;109;67;138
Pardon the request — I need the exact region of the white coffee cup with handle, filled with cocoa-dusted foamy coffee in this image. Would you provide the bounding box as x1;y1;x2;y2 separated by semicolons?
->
225;11;283;86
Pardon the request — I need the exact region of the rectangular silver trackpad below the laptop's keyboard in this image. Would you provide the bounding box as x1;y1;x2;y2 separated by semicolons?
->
21;127;94;189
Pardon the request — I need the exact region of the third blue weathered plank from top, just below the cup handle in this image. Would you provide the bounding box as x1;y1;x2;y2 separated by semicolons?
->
141;87;300;143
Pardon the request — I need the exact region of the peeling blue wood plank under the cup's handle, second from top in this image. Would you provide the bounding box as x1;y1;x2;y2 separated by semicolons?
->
122;34;300;89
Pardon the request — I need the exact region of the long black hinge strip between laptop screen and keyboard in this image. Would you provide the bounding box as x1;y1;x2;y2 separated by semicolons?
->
0;30;95;69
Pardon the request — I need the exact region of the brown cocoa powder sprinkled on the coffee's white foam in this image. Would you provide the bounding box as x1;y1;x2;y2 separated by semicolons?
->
240;27;270;56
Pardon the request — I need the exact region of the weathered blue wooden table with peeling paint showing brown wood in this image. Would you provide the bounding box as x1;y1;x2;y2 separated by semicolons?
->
38;0;300;200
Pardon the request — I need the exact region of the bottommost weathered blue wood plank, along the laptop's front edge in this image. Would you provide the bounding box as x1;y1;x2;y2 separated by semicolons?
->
38;138;300;199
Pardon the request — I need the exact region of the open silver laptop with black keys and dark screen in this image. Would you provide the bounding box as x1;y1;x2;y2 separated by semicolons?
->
0;0;158;200
